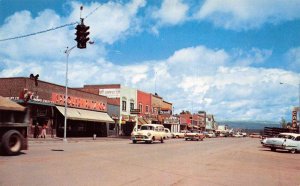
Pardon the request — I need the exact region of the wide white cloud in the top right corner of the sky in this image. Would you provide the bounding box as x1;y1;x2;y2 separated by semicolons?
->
195;0;300;30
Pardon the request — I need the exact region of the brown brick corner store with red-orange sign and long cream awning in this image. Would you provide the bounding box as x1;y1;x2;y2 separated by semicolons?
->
0;77;114;137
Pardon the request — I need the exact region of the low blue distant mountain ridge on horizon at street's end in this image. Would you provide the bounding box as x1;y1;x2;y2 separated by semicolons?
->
218;121;281;130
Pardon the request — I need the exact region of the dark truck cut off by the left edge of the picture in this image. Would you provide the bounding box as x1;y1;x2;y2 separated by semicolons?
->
0;96;29;156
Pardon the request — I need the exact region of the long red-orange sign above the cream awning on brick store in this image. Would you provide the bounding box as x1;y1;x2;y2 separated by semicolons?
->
52;93;106;111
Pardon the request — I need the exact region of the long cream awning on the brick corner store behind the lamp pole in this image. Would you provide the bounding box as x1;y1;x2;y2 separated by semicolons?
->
56;106;114;123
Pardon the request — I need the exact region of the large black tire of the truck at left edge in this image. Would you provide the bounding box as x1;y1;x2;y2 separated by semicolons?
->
2;130;24;155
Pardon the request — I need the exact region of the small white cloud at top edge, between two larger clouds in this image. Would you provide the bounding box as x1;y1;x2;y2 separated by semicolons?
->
152;0;189;25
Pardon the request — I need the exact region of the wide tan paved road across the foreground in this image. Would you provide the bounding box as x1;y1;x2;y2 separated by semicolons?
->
0;138;300;186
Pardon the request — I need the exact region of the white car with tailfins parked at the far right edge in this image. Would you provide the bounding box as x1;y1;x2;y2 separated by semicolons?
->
261;133;298;151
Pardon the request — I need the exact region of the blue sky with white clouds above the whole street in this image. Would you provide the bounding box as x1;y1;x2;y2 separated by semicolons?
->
0;0;300;122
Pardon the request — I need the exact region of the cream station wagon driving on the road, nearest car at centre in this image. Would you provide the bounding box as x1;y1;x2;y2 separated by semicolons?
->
131;124;165;143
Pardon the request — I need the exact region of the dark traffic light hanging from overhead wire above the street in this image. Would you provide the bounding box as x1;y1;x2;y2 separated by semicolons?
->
75;19;90;49
